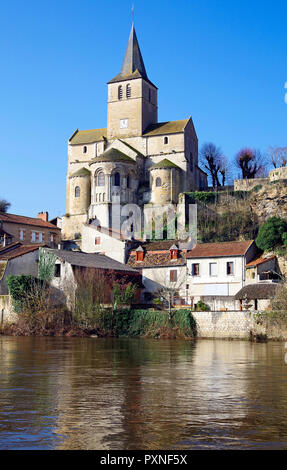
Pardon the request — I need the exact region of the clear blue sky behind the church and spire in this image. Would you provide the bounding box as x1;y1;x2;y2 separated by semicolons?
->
0;0;287;217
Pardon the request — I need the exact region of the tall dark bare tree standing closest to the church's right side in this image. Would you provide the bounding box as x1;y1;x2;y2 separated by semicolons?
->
199;142;226;188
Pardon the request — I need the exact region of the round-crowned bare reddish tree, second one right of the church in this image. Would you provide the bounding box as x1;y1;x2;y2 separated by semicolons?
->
235;147;266;179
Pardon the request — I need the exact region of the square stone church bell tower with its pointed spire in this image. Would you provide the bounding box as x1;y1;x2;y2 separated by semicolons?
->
107;24;158;140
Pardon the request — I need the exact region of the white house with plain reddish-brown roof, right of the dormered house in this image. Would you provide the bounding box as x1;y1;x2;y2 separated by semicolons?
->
186;240;258;310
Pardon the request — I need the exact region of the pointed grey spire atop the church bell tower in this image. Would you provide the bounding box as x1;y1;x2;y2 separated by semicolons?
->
109;22;149;83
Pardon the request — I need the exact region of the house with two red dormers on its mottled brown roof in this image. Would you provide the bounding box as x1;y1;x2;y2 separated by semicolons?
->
127;240;189;305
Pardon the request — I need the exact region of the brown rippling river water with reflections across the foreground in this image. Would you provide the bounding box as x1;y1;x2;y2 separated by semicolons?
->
0;336;287;450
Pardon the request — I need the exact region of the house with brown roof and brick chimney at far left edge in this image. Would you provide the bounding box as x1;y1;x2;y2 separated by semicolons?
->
0;212;61;247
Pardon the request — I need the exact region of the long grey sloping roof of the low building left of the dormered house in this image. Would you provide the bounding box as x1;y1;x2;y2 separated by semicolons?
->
46;248;138;273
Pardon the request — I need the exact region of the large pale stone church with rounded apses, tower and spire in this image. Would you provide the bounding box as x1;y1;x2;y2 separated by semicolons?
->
62;24;207;240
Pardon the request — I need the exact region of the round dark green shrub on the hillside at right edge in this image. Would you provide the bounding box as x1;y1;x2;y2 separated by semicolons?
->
256;217;287;251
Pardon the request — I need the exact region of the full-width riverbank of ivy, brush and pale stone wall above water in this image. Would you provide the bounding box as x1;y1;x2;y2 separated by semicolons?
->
2;309;287;342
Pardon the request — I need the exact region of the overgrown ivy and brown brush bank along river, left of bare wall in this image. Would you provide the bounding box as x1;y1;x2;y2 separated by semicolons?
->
2;308;196;339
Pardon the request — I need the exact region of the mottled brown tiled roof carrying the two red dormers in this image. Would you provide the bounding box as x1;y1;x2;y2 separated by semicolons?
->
127;250;186;268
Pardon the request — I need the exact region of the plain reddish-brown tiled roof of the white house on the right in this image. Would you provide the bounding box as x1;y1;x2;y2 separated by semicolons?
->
186;240;254;258
